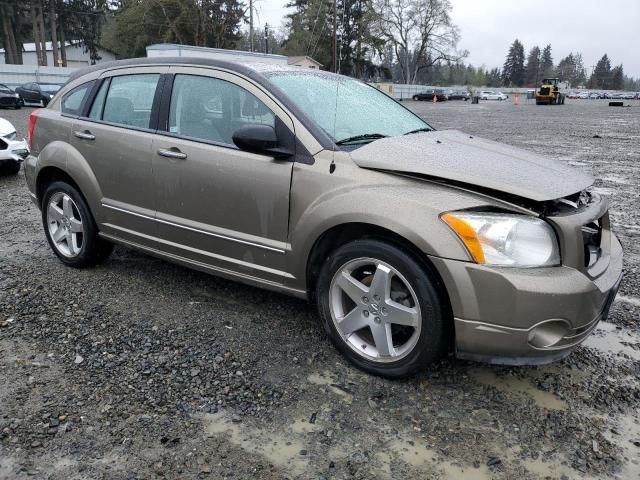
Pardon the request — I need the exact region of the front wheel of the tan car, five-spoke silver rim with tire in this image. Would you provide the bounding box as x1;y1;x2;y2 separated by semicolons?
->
316;239;448;378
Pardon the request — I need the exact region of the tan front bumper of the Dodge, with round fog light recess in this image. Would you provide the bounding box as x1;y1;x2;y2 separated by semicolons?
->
431;199;622;365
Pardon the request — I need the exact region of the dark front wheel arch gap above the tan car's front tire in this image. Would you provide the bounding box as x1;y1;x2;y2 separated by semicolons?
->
306;222;455;349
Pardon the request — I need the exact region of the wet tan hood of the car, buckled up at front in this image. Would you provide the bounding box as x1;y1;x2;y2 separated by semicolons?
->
351;130;593;201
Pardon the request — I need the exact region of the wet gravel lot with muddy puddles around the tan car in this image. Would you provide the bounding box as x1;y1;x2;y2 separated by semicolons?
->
0;101;640;480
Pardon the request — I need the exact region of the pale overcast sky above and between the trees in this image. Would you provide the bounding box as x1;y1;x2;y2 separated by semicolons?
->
252;0;640;78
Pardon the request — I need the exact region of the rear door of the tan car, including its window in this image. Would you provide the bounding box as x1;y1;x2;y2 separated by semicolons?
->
71;67;166;246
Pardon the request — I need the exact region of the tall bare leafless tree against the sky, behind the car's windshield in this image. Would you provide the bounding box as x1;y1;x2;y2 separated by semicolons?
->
375;0;466;83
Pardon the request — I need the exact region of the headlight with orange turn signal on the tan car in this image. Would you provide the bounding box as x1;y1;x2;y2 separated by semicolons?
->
441;212;560;267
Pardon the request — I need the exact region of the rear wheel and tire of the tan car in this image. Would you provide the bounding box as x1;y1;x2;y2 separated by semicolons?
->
42;181;113;268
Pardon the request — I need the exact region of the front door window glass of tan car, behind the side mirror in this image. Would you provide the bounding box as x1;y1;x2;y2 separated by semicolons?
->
169;75;275;145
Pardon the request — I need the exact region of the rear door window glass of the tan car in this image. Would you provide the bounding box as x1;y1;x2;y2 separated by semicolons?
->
102;73;160;128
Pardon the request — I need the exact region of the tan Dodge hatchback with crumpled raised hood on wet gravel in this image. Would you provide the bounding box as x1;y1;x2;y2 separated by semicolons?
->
25;57;622;378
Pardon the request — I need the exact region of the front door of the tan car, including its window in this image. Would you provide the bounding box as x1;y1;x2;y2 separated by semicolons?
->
152;67;293;283
